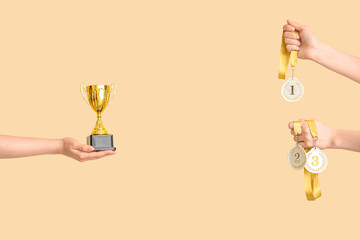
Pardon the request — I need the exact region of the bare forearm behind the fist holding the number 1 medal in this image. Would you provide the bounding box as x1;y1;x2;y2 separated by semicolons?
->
311;43;360;83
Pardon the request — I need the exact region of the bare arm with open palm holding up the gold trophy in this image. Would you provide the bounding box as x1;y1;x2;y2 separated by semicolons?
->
0;135;115;162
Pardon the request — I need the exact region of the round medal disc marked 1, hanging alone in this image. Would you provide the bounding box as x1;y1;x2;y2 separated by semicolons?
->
281;77;304;102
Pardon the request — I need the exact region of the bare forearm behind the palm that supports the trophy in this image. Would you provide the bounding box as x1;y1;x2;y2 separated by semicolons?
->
0;135;62;158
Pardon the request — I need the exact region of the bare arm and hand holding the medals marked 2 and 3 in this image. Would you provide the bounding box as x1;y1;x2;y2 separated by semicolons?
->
288;119;360;152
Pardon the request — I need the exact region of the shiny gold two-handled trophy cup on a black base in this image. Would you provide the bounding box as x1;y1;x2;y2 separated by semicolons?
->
80;83;116;151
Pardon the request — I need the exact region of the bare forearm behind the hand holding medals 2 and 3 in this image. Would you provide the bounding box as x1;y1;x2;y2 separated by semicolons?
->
332;129;360;152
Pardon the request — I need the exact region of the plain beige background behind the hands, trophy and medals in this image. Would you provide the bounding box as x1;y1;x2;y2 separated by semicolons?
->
0;0;360;240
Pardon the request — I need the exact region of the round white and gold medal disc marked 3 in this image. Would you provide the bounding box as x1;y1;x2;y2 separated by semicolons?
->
305;148;327;173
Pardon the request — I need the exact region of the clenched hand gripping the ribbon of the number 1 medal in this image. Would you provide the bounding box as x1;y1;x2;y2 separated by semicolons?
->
283;19;320;60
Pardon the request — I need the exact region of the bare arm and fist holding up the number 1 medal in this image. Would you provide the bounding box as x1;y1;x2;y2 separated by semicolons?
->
283;20;360;83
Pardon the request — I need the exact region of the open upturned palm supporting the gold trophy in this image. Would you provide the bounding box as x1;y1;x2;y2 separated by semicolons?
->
60;138;116;162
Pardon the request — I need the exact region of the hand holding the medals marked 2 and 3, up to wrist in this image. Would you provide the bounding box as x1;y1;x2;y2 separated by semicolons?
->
288;119;335;149
